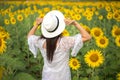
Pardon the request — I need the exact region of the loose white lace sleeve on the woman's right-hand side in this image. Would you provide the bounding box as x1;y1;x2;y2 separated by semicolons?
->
71;34;83;56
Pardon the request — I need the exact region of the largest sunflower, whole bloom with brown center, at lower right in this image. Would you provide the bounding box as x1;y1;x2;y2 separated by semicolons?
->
84;50;104;68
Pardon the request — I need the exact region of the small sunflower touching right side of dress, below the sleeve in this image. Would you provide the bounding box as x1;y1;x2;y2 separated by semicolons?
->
69;58;80;70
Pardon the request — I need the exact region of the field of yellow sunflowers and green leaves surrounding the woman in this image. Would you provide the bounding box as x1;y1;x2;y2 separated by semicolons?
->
0;0;120;80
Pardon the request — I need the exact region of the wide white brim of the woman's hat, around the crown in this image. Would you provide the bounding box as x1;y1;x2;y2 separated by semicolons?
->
41;10;66;38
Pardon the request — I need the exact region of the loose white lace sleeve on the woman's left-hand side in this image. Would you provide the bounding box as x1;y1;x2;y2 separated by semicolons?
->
28;35;39;58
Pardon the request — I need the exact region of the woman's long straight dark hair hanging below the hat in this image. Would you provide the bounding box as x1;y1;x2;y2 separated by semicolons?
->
41;34;61;62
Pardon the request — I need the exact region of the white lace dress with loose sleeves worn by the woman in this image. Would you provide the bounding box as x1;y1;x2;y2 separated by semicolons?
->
28;34;83;80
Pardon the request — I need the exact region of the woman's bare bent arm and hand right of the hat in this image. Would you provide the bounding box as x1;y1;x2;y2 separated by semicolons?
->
65;19;91;42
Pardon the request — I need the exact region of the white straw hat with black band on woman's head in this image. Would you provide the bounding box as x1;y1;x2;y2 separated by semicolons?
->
41;10;65;38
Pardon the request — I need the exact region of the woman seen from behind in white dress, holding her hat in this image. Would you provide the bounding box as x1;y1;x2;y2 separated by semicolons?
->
28;10;91;80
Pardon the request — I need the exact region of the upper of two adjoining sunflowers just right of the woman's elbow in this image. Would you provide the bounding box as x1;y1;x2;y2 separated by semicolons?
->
91;27;103;38
